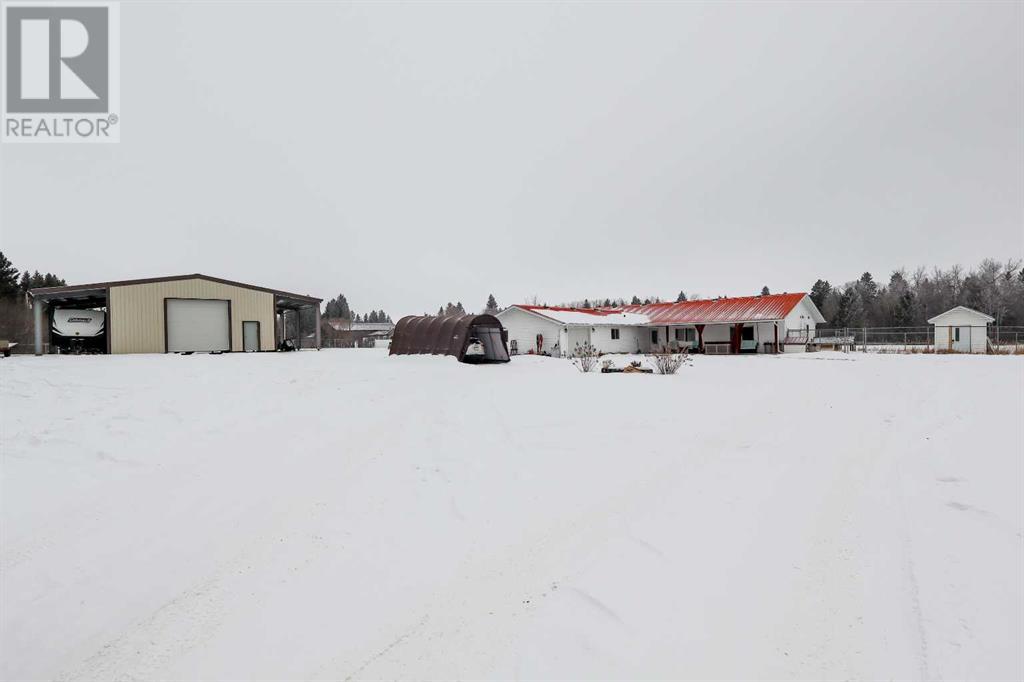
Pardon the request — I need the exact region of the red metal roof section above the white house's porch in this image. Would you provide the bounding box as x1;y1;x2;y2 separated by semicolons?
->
623;293;807;325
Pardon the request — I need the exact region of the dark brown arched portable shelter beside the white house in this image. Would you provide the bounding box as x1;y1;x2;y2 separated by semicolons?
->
389;314;509;363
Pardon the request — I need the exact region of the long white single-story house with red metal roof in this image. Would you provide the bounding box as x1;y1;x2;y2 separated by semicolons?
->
498;293;824;357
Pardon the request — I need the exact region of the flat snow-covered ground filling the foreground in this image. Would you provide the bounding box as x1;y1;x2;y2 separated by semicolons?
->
0;350;1024;680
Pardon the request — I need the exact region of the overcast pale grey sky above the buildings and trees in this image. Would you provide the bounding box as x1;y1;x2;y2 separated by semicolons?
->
0;2;1024;318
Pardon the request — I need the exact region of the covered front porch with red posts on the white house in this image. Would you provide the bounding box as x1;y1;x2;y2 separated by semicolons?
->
638;319;785;355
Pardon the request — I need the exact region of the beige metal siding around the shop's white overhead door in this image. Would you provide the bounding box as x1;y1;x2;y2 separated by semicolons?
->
109;280;273;353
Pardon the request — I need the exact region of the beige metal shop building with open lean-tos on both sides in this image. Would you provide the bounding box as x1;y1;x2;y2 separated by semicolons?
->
30;273;322;355
